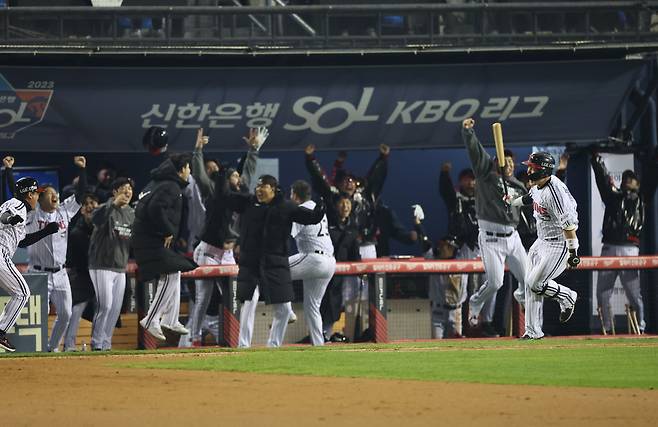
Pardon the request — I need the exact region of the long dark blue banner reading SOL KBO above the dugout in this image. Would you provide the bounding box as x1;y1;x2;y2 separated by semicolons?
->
0;60;647;152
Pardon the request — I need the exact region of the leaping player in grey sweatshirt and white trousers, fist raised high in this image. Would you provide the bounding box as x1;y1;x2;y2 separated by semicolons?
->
462;119;528;336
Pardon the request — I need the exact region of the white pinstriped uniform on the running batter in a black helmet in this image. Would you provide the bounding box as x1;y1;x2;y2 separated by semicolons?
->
525;176;578;338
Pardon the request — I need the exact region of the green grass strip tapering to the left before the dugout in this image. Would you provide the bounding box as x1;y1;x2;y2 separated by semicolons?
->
113;338;658;389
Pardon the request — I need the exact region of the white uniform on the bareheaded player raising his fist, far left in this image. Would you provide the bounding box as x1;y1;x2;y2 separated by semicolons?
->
25;195;80;351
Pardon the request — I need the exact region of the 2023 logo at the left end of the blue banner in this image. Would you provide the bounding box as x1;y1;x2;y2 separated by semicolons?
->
0;74;54;139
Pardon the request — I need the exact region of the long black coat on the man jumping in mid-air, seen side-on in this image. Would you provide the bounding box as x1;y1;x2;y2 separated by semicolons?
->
131;160;198;281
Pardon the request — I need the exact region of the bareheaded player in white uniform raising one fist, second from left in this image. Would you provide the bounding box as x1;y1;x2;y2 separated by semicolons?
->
25;156;87;351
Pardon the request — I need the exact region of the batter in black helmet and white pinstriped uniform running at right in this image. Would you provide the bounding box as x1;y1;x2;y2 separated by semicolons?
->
504;152;580;339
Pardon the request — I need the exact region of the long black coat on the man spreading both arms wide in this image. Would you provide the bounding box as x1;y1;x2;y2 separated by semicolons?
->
224;191;324;304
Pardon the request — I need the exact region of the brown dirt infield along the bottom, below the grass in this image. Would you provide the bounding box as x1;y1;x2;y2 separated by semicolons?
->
0;354;658;427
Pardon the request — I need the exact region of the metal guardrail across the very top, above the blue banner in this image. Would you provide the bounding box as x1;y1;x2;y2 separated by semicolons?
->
0;1;658;54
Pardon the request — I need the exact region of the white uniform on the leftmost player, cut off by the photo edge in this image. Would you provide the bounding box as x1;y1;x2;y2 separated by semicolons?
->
0;199;30;332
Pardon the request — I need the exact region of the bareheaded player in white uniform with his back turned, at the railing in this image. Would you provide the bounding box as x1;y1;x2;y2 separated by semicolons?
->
289;180;336;345
